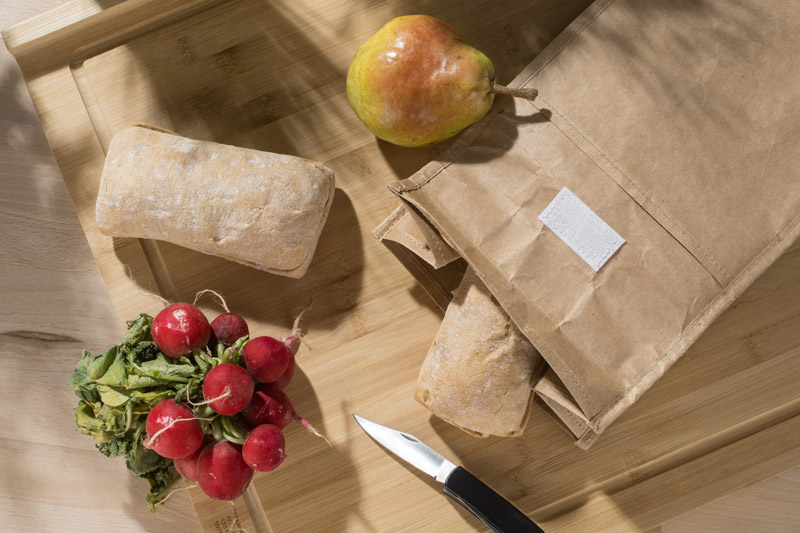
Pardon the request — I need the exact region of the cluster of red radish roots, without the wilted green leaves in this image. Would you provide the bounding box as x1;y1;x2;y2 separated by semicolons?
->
145;303;313;500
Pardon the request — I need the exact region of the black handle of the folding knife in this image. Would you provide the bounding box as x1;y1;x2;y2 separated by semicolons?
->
442;466;543;533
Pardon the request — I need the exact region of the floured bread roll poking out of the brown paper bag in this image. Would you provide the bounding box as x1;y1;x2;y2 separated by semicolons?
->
414;268;542;437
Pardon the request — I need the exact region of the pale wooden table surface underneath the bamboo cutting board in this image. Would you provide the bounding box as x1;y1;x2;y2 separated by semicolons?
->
0;0;800;532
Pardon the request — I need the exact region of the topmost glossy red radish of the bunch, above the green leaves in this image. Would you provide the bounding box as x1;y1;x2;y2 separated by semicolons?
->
151;302;211;359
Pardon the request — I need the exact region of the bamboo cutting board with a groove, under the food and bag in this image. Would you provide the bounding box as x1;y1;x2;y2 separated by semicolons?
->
3;0;800;532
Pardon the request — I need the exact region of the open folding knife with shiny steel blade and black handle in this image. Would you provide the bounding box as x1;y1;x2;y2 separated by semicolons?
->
353;415;542;533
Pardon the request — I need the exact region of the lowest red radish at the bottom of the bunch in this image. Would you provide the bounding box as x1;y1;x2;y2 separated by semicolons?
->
197;440;253;500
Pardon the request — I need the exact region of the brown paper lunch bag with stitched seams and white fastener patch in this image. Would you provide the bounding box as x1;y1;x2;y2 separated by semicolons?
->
376;0;800;447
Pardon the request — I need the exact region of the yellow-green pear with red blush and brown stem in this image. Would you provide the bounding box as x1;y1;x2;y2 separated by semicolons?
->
347;15;537;147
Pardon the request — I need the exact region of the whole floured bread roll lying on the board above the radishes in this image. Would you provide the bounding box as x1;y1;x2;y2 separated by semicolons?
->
96;125;335;278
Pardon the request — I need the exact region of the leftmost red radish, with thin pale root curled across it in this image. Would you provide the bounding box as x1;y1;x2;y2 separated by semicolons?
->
145;398;203;459
